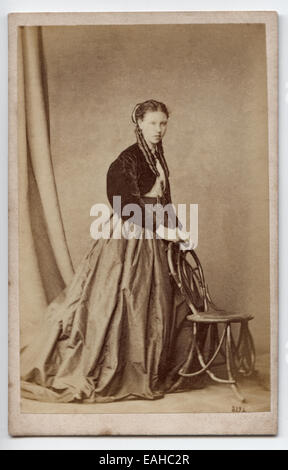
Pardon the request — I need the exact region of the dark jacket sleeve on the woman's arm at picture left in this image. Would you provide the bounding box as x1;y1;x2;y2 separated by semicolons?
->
107;153;159;232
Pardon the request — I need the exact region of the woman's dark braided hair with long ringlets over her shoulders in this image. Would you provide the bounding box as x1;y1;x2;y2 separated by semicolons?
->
131;100;169;178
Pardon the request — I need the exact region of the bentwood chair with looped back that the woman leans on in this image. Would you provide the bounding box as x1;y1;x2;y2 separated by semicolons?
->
167;242;255;402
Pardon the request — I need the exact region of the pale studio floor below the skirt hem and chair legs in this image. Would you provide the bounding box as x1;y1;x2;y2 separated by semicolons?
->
21;354;270;414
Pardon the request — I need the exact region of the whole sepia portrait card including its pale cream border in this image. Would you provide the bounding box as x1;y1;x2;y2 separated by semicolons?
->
9;12;278;435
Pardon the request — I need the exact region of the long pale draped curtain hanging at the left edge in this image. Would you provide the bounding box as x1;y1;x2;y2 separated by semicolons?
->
18;27;73;346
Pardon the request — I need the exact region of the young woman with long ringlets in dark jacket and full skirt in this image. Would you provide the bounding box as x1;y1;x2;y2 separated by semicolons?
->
21;100;202;403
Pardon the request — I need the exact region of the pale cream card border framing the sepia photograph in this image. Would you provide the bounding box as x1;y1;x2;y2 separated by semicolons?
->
8;11;278;436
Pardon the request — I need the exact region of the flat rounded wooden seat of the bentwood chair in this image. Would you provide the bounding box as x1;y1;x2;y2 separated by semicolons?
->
186;305;254;323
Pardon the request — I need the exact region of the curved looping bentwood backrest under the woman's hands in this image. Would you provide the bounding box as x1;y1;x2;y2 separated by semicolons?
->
168;242;213;315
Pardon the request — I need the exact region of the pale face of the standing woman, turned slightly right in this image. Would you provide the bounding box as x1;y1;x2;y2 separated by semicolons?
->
138;111;168;147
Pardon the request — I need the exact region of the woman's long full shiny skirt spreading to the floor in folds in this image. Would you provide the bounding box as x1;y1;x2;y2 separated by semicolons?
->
21;214;203;403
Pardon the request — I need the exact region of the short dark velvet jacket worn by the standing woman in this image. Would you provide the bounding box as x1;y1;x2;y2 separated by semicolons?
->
107;143;178;229
